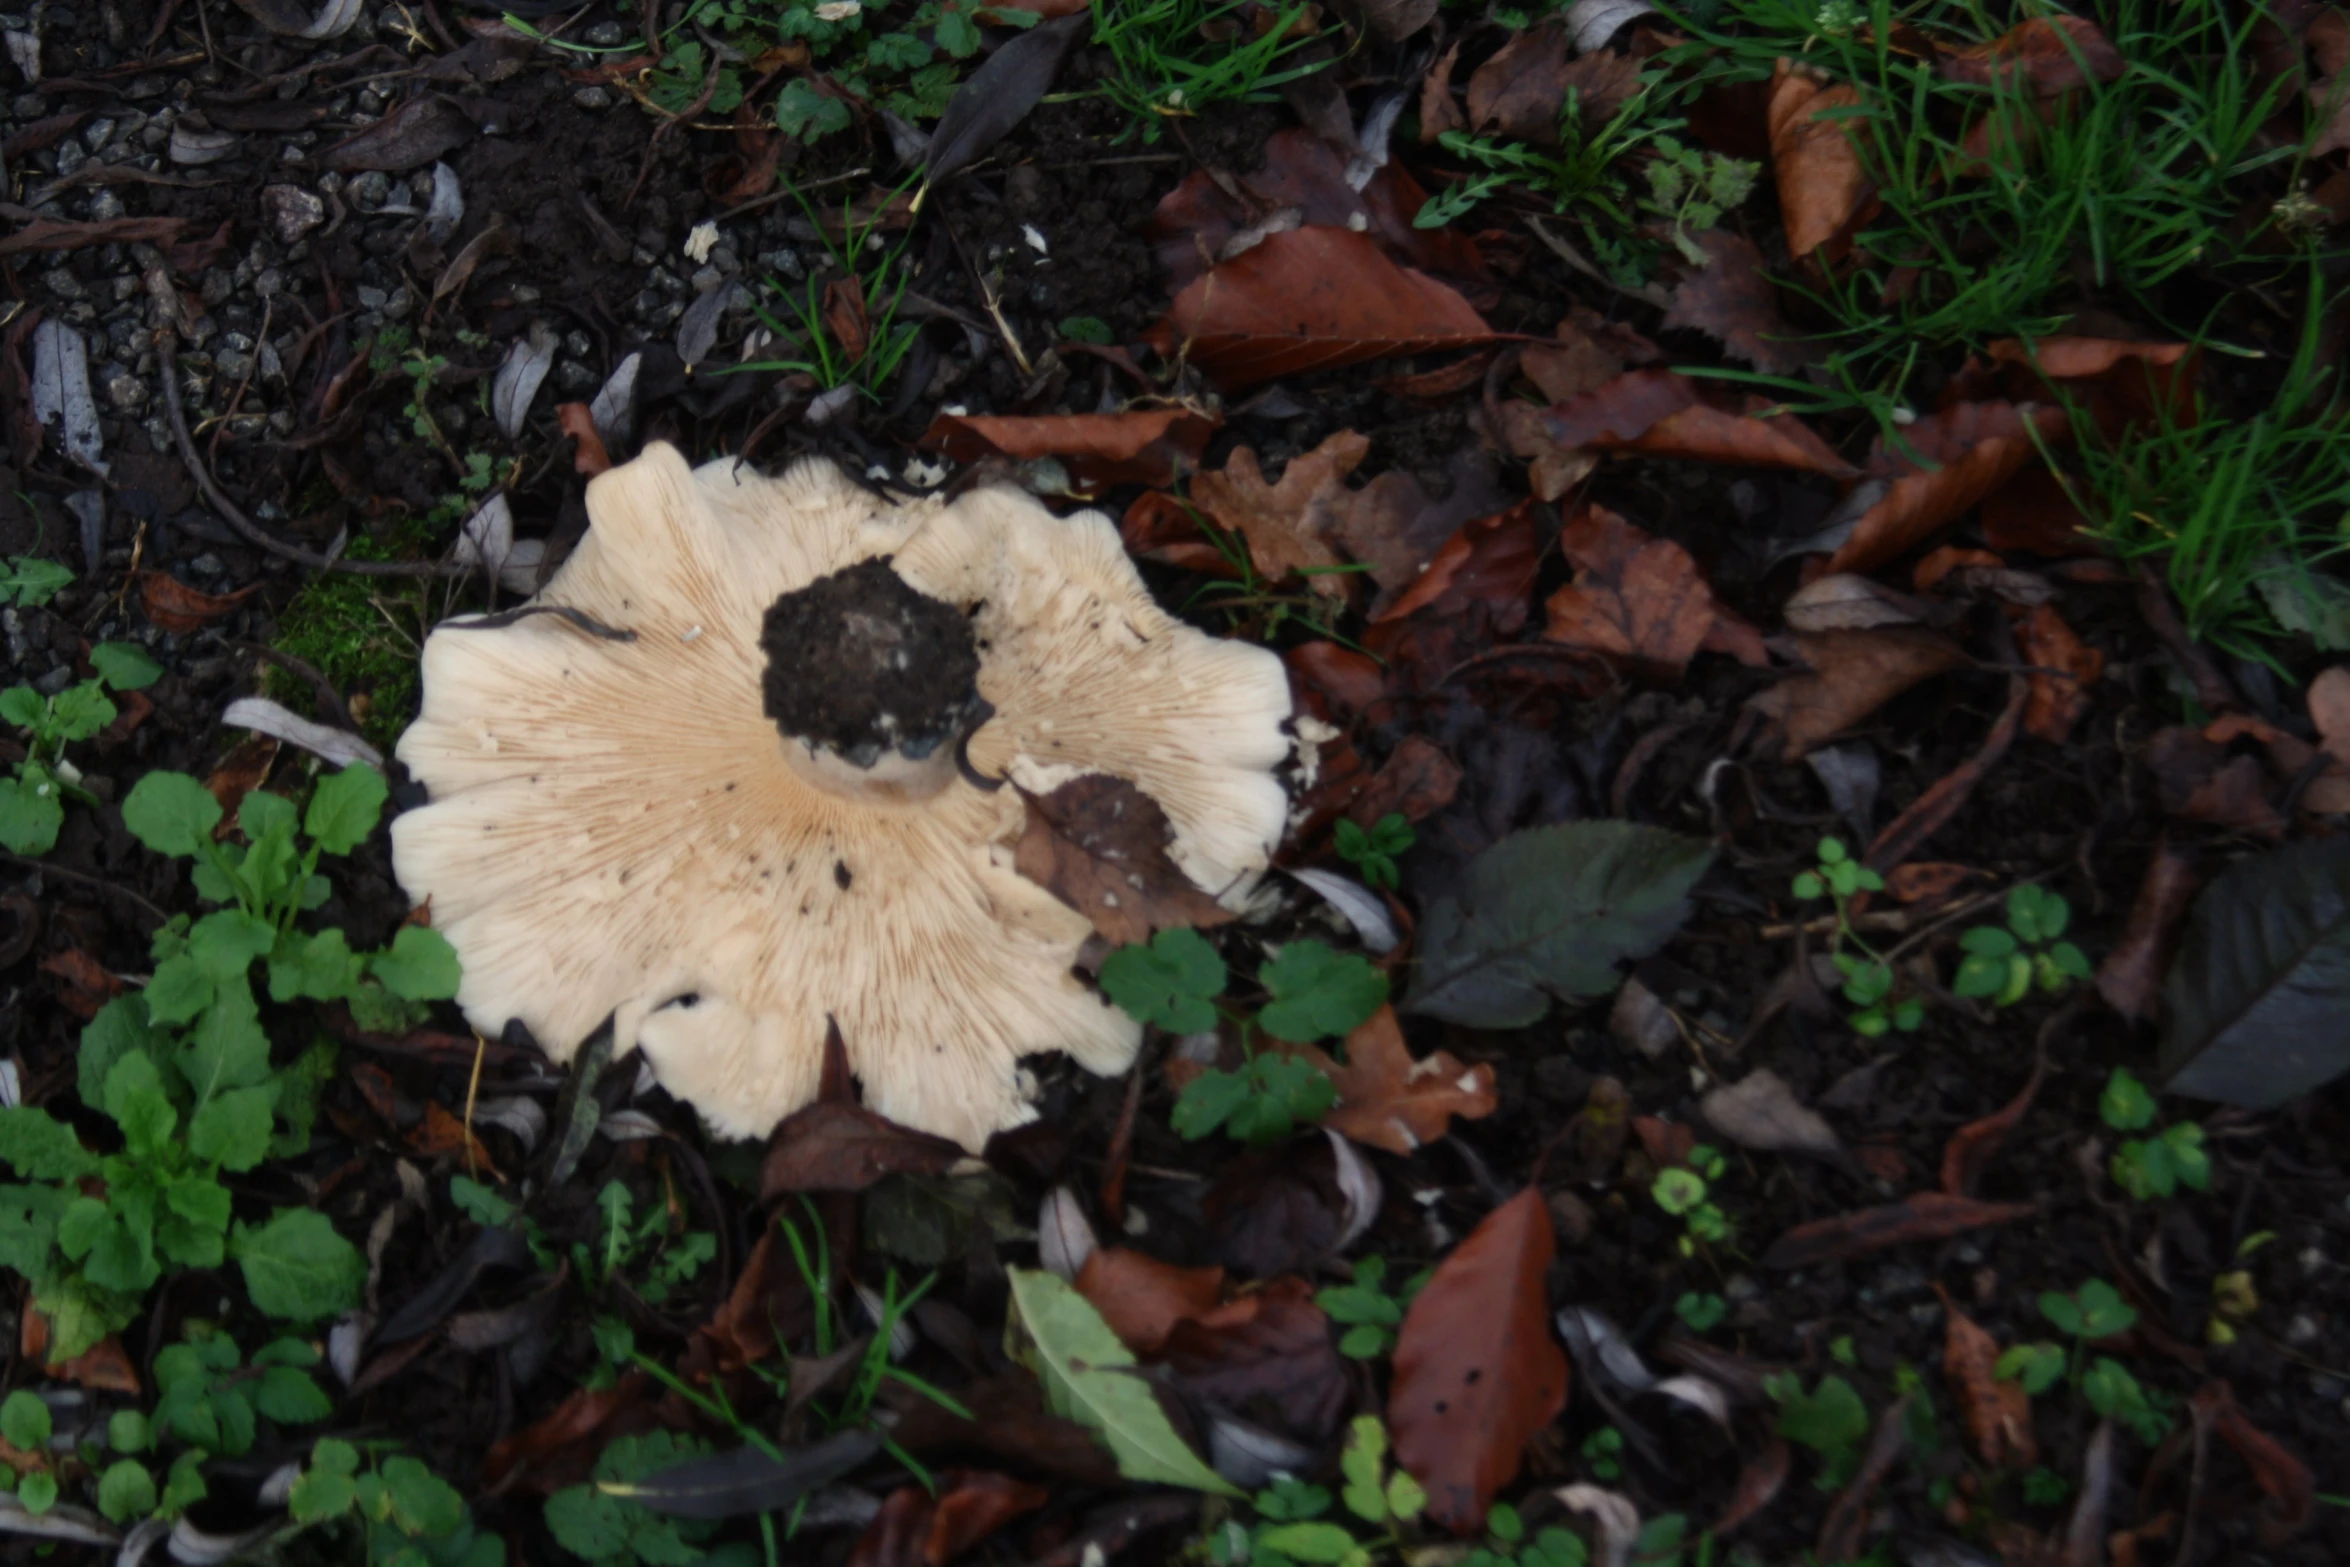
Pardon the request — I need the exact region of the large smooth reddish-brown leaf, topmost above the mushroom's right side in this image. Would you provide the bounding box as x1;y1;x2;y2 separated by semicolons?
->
1152;228;1495;388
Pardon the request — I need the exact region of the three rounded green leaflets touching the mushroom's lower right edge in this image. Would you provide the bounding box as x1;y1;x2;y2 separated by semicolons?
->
1102;928;1387;1146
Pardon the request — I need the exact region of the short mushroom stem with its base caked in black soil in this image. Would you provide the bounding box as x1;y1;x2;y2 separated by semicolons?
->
759;557;992;801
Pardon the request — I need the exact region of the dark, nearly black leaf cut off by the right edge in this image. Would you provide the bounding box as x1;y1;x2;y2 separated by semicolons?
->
2160;839;2350;1109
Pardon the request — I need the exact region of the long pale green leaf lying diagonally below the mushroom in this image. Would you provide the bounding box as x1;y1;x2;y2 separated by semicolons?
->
1011;1269;1241;1497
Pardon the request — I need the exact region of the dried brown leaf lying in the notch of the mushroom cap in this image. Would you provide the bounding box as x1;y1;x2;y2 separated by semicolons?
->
1013;773;1231;947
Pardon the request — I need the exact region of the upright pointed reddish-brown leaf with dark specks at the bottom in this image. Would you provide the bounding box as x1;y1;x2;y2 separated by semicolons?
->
1387;1186;1567;1536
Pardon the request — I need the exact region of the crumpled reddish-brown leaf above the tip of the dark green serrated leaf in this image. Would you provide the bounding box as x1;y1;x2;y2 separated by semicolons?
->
1542;505;1716;681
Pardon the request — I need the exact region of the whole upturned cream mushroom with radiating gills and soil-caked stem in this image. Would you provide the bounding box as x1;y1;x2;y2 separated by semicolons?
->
392;444;1290;1149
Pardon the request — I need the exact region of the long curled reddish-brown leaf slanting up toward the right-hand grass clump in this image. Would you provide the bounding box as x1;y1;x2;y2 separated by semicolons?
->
1828;402;2066;571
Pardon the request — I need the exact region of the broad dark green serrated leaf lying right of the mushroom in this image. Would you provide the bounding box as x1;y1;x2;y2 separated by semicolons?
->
1403;822;1713;1029
